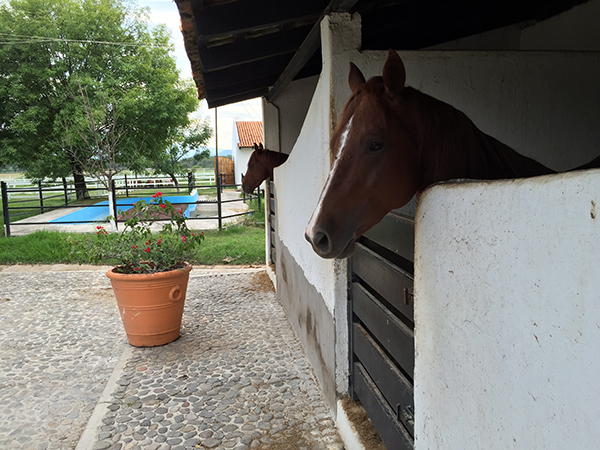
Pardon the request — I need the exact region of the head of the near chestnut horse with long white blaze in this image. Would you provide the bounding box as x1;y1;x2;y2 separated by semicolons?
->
305;50;421;258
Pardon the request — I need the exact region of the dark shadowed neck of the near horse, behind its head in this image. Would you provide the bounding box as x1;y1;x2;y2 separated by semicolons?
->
409;89;554;187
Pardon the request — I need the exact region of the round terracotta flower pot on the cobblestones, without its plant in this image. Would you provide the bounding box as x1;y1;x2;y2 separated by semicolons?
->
106;263;192;347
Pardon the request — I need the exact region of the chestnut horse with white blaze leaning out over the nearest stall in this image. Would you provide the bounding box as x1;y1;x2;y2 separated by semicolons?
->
305;50;600;258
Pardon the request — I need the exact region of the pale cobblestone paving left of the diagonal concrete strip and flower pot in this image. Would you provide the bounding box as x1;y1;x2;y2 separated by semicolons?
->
0;272;127;450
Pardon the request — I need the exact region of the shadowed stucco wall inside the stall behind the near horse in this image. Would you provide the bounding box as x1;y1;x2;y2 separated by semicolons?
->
326;50;600;170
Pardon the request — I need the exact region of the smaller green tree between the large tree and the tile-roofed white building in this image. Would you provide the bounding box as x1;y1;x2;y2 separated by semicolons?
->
152;118;213;191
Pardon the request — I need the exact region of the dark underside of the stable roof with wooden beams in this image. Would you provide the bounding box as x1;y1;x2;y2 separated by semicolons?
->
175;0;584;107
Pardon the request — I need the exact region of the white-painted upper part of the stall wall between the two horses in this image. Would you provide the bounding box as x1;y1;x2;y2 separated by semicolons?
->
275;15;360;314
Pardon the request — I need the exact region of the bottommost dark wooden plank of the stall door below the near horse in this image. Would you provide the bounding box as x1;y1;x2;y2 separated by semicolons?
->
353;363;414;450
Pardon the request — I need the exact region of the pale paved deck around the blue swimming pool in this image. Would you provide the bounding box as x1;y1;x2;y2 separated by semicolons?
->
10;190;249;236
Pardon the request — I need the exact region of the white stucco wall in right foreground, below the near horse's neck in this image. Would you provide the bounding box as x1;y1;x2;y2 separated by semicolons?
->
415;170;600;450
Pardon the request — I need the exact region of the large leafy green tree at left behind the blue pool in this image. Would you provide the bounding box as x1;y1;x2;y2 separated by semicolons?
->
0;0;198;197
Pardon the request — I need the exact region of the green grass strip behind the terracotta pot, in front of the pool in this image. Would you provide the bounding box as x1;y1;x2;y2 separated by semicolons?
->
0;225;265;265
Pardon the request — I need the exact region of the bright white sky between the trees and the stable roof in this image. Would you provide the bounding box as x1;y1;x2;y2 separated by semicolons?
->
138;0;262;150
